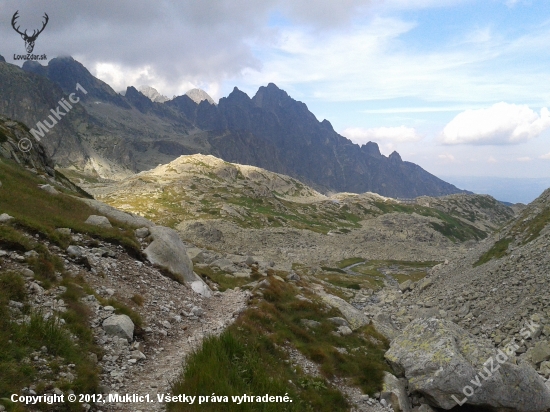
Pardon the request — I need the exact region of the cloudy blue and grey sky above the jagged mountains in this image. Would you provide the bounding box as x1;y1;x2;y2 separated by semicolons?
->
0;0;550;193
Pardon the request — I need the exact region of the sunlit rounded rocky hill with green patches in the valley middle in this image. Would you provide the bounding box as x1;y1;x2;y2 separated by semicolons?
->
83;155;513;266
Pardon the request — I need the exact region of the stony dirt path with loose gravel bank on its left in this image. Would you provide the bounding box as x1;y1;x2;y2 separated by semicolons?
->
68;244;249;412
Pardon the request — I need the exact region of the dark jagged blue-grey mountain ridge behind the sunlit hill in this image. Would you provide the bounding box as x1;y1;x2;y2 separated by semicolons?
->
0;57;461;197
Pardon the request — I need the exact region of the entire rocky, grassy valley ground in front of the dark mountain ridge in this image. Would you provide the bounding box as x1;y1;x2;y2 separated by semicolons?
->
0;119;550;412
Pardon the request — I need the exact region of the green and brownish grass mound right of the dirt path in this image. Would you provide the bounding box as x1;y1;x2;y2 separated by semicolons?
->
169;277;387;411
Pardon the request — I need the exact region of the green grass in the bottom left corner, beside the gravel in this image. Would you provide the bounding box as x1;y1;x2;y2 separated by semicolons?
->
0;272;101;411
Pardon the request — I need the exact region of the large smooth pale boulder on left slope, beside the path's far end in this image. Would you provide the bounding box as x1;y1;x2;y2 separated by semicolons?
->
143;226;209;295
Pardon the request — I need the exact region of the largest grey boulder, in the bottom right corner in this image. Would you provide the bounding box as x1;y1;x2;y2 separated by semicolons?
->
386;318;550;412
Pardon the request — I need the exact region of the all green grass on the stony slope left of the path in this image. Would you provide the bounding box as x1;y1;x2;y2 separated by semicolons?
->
0;160;140;410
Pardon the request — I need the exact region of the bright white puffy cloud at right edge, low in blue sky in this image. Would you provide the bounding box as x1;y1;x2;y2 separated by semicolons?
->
442;102;550;145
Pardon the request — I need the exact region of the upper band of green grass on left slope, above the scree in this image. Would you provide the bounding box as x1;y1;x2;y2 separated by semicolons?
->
0;161;140;256
